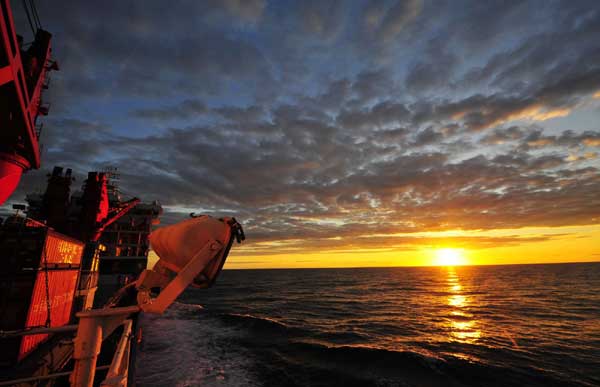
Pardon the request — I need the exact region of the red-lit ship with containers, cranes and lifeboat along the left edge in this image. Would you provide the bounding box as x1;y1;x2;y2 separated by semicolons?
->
0;0;245;387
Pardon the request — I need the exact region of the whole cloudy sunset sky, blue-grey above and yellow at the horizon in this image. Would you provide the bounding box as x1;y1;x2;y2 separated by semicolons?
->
4;0;600;268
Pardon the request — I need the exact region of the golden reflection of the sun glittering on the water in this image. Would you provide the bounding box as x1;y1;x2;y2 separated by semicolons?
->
447;266;482;344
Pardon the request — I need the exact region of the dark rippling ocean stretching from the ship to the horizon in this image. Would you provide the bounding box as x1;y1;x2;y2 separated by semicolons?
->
136;263;600;386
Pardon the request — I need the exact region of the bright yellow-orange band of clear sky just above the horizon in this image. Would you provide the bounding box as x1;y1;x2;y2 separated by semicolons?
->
226;225;600;269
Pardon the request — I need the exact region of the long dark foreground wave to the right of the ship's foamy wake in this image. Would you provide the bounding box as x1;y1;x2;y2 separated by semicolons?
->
211;313;568;387
